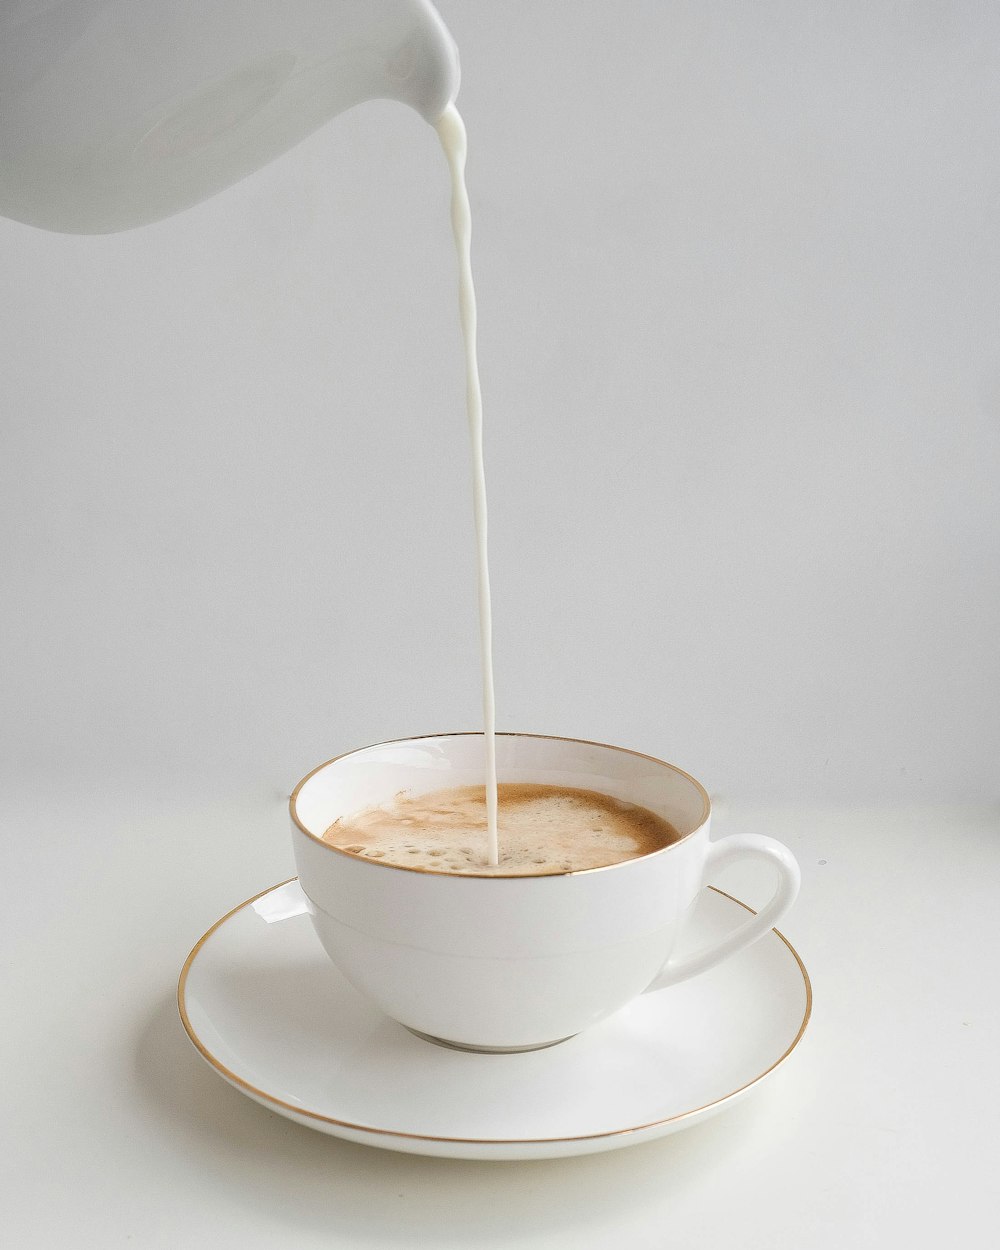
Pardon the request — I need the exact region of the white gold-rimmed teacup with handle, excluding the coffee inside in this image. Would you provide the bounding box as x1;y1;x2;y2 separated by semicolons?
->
291;734;799;1053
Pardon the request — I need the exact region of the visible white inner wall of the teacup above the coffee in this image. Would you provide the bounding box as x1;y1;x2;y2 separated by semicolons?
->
291;734;710;838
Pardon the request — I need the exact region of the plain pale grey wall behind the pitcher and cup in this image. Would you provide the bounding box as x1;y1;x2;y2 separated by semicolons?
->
0;0;1000;801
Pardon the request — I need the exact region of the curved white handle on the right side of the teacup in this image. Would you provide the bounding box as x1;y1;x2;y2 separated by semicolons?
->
644;834;800;994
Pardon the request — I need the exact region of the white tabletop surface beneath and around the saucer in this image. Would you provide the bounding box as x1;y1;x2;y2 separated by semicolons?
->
0;788;1000;1250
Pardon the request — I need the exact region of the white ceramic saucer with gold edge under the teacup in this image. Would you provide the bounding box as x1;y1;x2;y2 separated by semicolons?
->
178;880;813;1159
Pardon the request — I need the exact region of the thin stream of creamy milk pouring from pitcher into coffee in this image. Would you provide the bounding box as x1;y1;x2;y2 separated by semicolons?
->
436;104;500;866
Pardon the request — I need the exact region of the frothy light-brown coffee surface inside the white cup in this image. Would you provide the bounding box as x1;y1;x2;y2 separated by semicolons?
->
323;783;680;876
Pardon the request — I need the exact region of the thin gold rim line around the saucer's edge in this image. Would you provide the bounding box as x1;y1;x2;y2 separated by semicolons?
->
178;880;813;1146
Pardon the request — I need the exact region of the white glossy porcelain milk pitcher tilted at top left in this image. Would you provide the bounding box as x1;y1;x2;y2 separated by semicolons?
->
0;0;459;234
